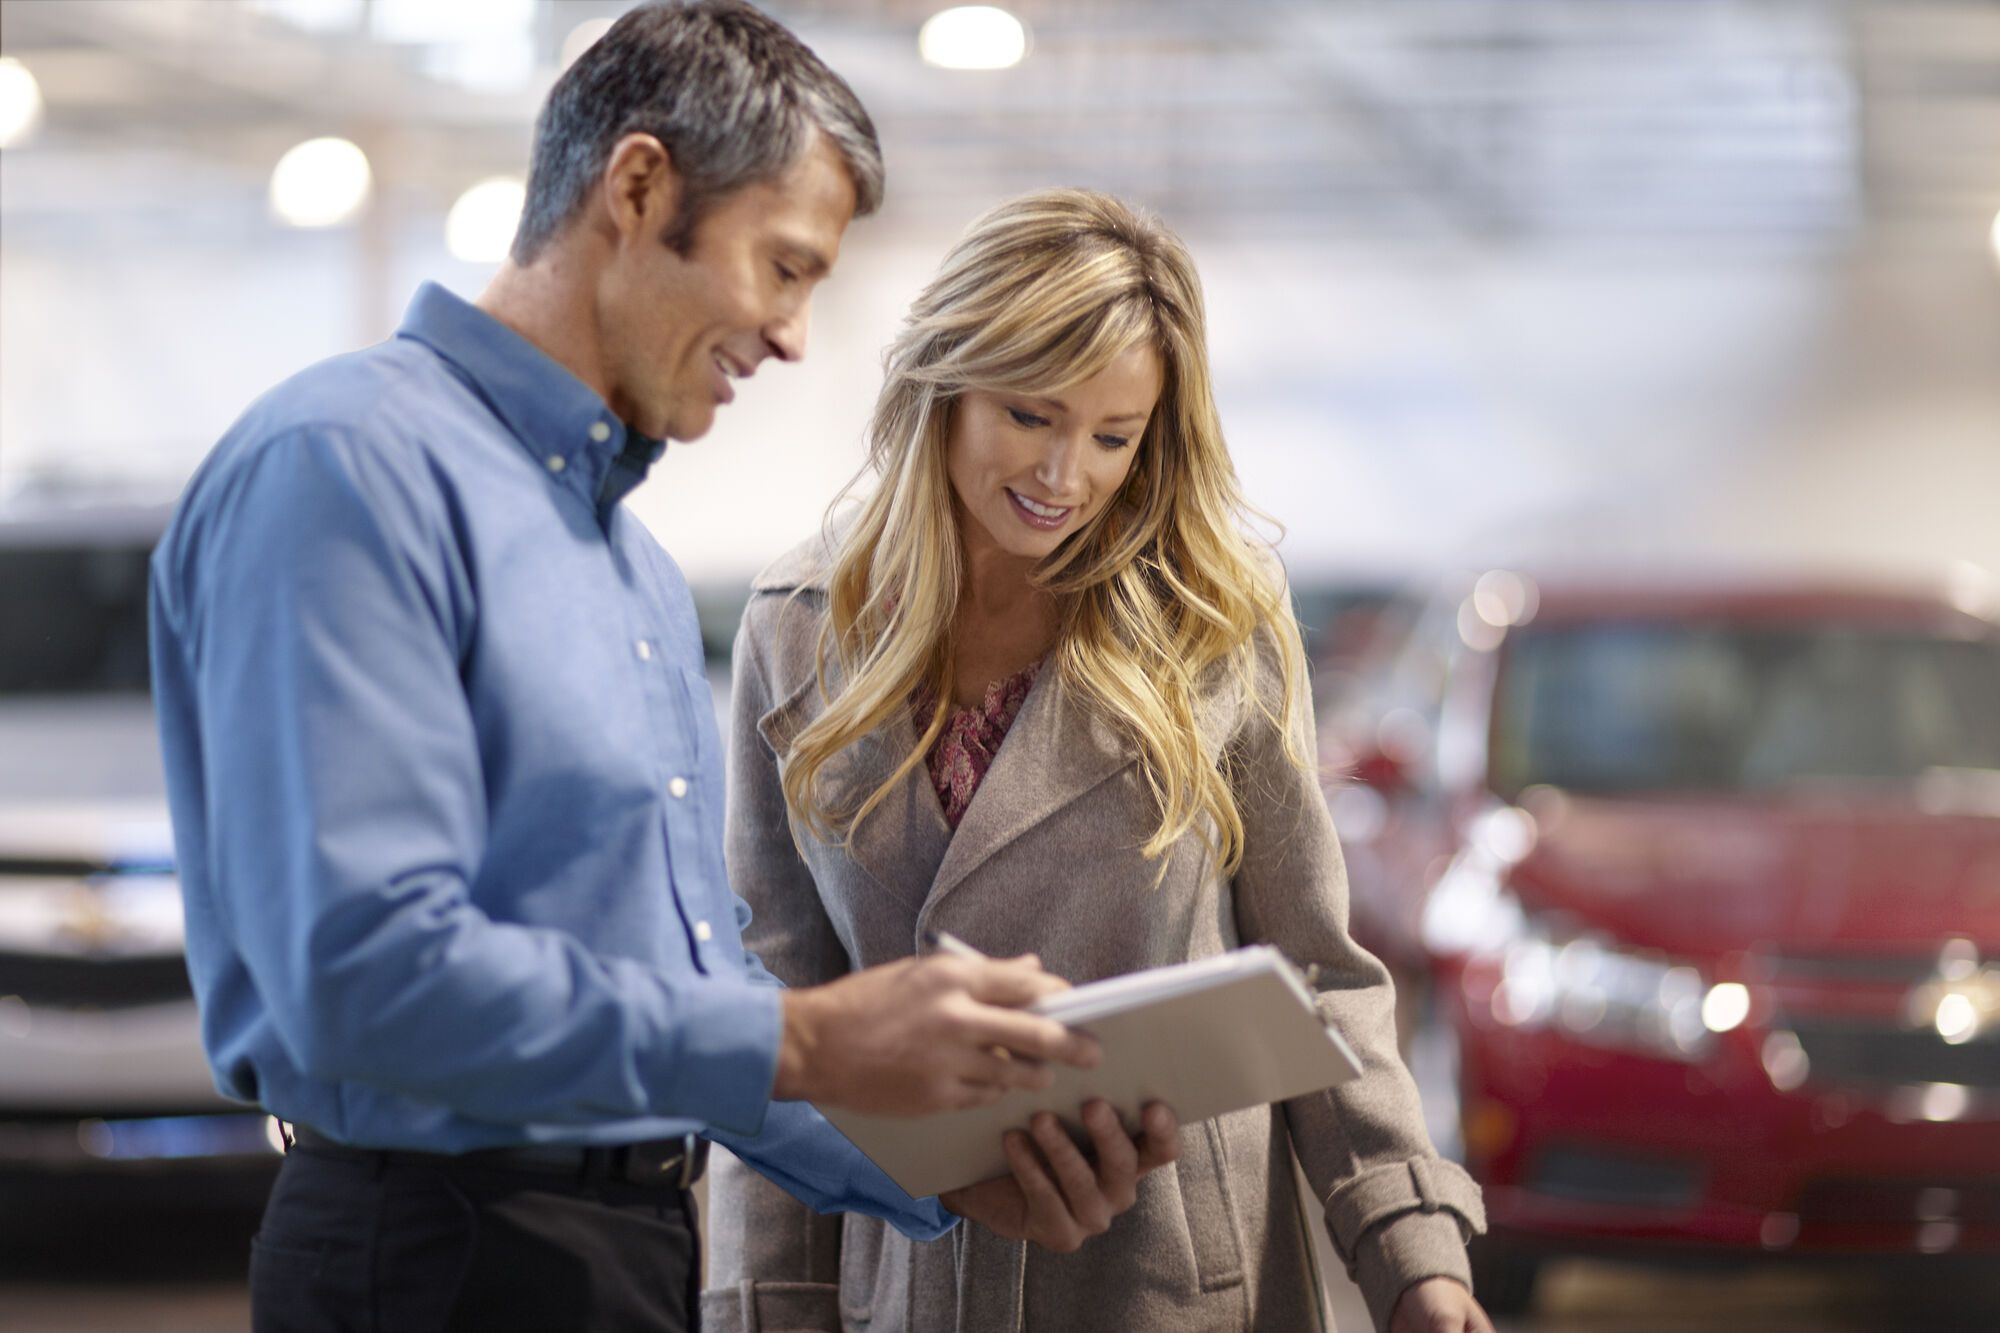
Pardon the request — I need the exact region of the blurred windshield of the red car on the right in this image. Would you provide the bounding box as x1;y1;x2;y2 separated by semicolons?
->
1492;622;2000;795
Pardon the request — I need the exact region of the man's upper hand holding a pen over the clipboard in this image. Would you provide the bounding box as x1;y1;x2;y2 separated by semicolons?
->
772;955;1102;1115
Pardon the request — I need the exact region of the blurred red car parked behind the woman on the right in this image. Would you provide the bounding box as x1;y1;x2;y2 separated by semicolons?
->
1322;572;2000;1311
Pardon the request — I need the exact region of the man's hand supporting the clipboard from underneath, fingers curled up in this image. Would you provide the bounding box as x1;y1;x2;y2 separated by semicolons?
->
938;1101;1180;1255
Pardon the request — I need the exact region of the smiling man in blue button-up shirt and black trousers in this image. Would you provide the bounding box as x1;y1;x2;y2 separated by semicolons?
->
152;0;1176;1333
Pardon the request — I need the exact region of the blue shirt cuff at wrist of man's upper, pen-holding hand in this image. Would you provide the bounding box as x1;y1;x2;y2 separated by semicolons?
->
646;979;784;1135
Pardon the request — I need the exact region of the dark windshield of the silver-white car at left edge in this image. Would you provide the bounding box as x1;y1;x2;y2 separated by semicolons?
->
0;544;148;699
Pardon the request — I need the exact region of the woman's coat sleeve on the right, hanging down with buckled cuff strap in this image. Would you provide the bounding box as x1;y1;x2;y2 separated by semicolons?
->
1228;620;1486;1329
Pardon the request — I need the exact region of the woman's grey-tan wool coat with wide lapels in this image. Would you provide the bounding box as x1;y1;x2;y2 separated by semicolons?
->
702;538;1484;1333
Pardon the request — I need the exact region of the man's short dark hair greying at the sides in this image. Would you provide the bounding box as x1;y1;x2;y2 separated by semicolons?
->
512;0;882;264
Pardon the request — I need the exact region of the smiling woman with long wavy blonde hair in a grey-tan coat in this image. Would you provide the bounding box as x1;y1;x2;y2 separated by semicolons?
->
704;190;1486;1333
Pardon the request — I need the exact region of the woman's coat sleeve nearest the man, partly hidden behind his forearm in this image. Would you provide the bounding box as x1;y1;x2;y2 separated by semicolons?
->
702;592;848;1333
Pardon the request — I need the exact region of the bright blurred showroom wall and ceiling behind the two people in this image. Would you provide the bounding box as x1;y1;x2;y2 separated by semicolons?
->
0;0;2000;584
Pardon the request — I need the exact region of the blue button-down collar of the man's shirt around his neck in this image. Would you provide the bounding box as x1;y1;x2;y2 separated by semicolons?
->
396;282;666;508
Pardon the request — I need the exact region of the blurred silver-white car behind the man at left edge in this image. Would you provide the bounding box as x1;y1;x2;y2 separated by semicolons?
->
0;496;278;1197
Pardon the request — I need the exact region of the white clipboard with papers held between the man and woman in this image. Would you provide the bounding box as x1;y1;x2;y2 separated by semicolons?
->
820;945;1362;1199
